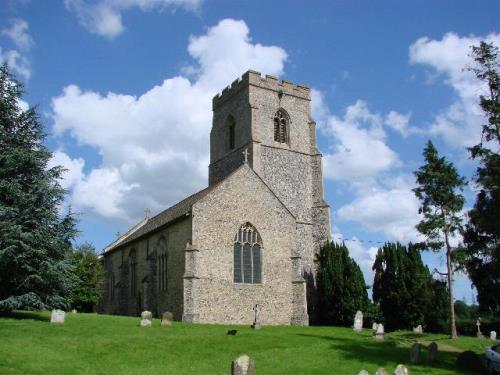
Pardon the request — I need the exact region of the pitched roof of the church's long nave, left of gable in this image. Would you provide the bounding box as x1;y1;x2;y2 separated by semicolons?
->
103;184;218;253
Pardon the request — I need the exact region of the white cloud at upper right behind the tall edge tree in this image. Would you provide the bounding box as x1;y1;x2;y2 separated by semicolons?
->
409;33;500;148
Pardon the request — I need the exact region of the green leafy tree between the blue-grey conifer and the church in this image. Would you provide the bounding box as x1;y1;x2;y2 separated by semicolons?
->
68;243;104;312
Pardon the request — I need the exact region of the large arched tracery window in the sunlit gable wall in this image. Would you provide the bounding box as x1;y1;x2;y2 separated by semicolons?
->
234;223;262;284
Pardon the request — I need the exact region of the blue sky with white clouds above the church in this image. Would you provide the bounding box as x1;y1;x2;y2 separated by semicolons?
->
0;0;500;303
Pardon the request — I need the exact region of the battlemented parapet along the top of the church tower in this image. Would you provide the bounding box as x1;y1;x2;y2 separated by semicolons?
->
212;70;311;108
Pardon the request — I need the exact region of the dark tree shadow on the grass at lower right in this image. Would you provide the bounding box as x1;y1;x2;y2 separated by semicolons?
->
298;334;481;375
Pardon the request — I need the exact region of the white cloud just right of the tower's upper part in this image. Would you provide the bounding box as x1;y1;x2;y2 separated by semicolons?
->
320;100;400;181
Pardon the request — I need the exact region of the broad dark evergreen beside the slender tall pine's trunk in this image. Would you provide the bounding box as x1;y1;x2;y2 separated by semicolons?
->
373;243;447;330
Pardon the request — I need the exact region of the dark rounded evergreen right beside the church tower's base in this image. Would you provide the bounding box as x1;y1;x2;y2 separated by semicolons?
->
316;241;369;326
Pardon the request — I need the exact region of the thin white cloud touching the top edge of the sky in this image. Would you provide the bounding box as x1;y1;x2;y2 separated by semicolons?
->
64;0;203;39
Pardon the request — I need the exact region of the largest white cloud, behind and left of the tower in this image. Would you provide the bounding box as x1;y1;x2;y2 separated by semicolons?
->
52;20;286;220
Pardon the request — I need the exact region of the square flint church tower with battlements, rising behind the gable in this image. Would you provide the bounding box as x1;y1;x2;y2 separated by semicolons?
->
209;70;330;313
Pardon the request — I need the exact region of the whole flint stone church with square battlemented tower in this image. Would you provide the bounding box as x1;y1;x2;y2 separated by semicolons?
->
99;70;330;325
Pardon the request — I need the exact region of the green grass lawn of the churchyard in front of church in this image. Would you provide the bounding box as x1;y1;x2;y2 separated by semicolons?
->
0;312;492;375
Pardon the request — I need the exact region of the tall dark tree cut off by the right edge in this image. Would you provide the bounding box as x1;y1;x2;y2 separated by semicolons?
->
462;42;500;315
